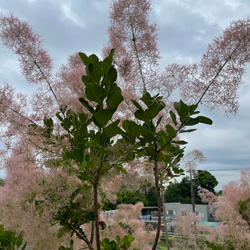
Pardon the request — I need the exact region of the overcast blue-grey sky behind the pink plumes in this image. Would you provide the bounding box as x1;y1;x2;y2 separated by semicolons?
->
0;0;250;190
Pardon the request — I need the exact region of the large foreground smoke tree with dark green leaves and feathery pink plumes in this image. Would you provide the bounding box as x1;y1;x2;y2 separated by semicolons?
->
0;0;250;249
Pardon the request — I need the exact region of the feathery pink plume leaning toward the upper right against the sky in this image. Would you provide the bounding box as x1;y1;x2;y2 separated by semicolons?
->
166;19;250;114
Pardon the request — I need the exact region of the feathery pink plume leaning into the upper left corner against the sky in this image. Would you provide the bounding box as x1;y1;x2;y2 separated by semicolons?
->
0;14;52;86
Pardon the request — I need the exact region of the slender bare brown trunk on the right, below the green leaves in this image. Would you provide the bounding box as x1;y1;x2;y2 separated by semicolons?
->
152;147;161;250
